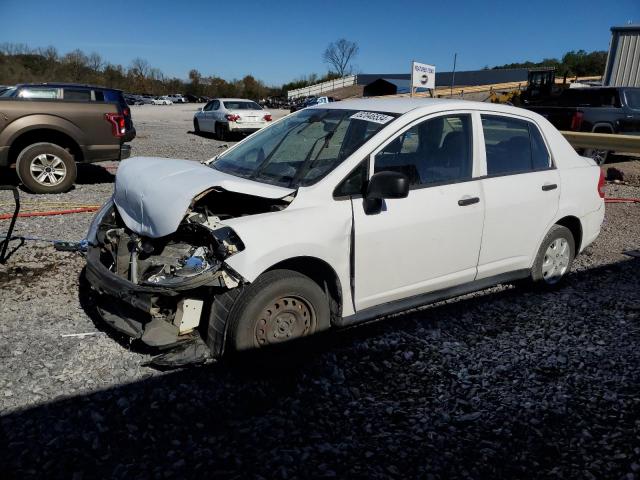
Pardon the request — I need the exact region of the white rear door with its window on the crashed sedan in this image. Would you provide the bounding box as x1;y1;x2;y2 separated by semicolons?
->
478;113;560;279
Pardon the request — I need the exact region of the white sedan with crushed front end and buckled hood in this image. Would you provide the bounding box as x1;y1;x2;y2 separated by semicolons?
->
86;99;604;365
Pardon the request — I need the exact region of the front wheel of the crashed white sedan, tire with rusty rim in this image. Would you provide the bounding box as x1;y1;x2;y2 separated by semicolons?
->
218;270;330;354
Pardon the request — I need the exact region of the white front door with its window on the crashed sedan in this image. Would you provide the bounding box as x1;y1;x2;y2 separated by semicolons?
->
352;112;484;311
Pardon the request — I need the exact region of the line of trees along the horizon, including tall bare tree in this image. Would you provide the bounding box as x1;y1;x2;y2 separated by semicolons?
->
0;39;607;100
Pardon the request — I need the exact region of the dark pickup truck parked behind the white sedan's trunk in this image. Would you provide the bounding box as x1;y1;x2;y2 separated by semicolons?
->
525;87;640;164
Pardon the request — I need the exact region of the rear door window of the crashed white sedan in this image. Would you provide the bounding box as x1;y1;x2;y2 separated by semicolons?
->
482;115;551;175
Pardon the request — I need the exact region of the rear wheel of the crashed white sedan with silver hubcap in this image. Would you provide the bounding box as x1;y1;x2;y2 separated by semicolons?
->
531;225;576;288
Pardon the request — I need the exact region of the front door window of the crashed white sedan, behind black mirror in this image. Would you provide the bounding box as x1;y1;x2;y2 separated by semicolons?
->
374;114;473;186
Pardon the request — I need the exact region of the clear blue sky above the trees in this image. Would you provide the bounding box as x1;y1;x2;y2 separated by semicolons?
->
0;0;640;85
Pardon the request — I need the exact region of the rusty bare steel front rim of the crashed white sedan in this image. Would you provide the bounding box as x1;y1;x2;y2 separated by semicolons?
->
254;296;316;347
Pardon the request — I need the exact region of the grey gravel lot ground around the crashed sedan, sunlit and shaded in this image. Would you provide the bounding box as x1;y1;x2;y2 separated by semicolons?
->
0;106;640;480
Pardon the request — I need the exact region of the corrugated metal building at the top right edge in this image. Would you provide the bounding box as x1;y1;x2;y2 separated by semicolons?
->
604;25;640;87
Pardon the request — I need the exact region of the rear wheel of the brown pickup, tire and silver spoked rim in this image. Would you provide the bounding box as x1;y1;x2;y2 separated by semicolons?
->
16;142;77;193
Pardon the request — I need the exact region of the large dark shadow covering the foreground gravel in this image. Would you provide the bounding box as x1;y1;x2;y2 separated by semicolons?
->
5;259;640;479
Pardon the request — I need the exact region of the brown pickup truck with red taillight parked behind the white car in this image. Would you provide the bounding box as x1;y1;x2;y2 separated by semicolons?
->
0;84;136;193
